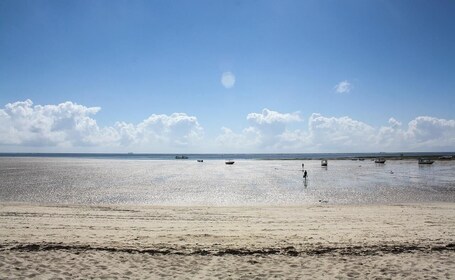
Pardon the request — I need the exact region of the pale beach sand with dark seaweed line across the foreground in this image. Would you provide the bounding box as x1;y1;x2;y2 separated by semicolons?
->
0;203;455;279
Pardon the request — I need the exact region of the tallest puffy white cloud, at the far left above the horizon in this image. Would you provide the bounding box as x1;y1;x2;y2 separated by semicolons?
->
0;99;103;146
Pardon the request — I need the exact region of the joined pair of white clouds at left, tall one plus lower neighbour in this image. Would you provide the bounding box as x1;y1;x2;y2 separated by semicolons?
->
0;100;203;152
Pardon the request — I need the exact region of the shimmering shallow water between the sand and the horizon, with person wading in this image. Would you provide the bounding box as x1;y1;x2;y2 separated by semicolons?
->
0;157;455;206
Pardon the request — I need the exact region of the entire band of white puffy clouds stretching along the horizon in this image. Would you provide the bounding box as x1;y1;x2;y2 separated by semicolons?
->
0;100;455;153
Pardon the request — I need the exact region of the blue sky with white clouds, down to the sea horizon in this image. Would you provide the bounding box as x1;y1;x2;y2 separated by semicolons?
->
0;0;455;153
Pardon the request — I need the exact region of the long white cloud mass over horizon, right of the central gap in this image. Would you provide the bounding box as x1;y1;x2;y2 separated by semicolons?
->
218;109;455;152
